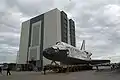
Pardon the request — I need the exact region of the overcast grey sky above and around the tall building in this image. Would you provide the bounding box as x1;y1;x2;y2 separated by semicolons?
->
0;0;120;62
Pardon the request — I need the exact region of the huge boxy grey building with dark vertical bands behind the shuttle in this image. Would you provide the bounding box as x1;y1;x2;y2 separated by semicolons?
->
18;9;76;67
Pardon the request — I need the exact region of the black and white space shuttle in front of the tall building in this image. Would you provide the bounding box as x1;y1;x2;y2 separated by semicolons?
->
43;40;110;65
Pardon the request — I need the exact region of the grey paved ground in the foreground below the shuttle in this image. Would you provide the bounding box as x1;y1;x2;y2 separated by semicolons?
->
0;71;120;80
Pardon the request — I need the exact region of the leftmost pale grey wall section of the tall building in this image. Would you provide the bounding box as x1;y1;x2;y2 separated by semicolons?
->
18;20;30;64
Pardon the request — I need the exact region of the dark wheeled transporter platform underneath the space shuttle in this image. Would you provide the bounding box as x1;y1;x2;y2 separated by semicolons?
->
44;65;92;73
